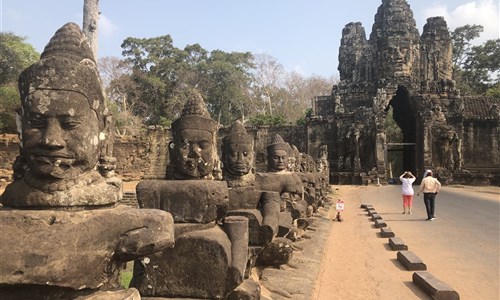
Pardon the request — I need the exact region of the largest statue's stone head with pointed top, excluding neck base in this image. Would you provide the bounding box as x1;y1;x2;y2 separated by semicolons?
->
19;23;109;180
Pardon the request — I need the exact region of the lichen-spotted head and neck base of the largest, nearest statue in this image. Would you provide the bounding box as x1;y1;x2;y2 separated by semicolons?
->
1;23;121;208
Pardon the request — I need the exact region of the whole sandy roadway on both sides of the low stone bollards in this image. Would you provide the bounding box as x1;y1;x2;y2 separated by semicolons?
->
311;186;500;300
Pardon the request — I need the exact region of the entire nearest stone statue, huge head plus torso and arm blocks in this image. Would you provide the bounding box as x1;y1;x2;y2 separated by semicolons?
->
0;23;174;299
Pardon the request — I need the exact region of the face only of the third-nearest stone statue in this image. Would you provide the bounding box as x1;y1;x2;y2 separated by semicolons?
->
224;144;254;176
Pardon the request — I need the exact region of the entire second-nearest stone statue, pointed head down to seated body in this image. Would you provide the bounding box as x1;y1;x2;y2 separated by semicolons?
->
131;91;251;299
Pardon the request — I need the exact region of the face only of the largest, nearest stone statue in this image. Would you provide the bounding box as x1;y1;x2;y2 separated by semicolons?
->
22;90;100;179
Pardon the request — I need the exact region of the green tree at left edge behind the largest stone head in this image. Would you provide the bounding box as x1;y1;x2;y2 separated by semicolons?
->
0;33;40;133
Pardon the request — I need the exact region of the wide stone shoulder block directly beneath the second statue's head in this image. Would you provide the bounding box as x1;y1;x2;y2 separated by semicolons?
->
136;180;229;223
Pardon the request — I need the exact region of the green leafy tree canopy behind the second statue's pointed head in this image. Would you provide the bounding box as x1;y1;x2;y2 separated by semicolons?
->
122;35;252;124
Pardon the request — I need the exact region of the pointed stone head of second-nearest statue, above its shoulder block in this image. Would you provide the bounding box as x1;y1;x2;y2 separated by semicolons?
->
170;91;218;179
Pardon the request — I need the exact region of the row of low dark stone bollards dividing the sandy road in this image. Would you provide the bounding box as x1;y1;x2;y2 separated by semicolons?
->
360;204;460;300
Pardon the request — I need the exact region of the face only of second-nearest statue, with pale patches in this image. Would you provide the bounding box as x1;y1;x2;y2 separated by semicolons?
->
173;129;215;179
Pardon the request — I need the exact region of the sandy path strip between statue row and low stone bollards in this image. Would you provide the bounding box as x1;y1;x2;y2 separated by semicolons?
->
312;186;428;300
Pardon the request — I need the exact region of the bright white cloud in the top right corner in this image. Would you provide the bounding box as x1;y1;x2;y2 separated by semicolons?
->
424;0;500;44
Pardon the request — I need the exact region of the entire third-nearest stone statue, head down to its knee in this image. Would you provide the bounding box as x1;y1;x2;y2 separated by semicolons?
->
222;121;292;266
